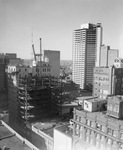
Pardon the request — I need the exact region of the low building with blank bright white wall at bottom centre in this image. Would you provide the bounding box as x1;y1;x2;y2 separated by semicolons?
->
32;117;73;150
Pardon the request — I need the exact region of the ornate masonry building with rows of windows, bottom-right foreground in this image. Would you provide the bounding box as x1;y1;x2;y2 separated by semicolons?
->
73;97;123;150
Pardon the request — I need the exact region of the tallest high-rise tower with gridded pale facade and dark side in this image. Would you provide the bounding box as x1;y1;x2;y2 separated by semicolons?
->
72;23;102;89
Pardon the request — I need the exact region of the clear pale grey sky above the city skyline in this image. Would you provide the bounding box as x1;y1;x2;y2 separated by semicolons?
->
0;0;123;60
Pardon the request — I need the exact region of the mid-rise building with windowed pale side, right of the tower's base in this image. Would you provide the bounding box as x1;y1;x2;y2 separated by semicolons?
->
93;66;123;99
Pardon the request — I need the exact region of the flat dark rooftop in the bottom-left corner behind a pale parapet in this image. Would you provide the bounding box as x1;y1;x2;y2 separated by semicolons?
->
0;125;31;150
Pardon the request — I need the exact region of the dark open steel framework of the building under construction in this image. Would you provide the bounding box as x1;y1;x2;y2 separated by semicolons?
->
9;76;62;130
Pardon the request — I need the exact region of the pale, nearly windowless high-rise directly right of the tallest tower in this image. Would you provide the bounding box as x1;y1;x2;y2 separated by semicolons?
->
100;45;119;67
